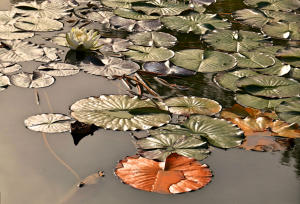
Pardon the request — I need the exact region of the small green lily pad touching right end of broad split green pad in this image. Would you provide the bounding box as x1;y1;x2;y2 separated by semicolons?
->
233;52;275;69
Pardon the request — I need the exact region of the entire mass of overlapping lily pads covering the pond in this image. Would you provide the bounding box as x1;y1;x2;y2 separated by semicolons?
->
0;0;300;193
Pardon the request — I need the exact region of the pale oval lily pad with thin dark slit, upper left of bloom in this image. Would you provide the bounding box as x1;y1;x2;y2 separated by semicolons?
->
14;17;64;31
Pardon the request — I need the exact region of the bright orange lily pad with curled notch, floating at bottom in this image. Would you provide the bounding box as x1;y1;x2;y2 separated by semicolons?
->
115;154;212;194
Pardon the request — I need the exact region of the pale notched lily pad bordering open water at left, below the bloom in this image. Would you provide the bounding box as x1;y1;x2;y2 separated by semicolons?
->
11;72;55;88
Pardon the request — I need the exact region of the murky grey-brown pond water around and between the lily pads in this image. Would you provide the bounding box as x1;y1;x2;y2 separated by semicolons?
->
0;0;300;204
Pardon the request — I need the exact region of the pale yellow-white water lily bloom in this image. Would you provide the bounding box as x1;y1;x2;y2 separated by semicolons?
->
66;28;102;50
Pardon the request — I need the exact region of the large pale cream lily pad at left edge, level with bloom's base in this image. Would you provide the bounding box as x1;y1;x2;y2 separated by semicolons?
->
0;40;44;62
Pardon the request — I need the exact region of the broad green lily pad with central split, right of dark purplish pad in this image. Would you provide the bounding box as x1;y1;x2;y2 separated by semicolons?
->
170;49;236;72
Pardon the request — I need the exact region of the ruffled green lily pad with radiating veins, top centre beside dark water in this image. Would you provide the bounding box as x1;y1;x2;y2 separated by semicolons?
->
161;14;231;35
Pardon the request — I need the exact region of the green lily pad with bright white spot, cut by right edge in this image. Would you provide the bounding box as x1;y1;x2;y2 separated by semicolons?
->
262;22;300;40
